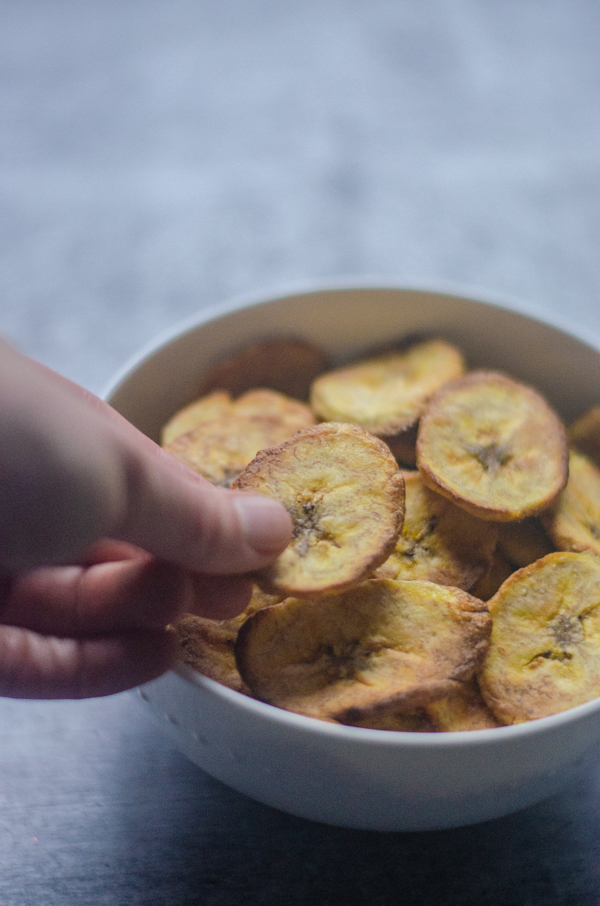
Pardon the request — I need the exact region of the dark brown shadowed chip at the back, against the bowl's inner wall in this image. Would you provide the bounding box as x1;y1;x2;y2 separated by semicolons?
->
201;337;329;400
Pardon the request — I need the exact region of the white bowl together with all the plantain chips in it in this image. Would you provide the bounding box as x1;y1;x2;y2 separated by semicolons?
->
105;284;600;831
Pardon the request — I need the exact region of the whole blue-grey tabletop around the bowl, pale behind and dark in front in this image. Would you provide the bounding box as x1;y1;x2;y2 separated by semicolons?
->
0;0;600;906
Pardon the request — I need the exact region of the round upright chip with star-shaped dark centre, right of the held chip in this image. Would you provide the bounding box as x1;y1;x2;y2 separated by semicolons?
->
417;371;568;522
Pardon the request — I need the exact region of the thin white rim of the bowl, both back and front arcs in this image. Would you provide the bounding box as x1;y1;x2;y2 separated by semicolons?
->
109;277;600;749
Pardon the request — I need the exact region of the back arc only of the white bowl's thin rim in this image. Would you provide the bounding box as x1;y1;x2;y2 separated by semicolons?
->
100;277;600;400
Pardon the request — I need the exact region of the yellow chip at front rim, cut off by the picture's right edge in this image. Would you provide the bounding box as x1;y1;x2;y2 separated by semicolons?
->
479;552;600;724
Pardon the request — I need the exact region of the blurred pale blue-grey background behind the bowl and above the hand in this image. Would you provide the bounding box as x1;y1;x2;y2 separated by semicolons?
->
0;0;600;391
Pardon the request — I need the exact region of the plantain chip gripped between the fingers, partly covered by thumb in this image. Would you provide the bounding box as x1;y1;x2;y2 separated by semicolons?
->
233;423;404;595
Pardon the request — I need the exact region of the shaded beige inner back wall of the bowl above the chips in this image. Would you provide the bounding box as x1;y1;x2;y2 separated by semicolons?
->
107;288;600;440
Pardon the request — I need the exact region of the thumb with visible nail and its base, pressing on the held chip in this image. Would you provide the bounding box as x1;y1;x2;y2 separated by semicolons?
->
0;347;291;574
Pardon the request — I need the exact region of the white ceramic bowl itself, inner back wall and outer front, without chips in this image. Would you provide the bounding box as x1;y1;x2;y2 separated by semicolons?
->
106;287;600;830
